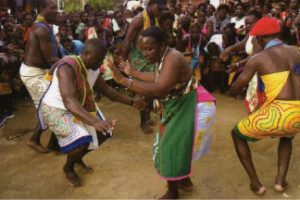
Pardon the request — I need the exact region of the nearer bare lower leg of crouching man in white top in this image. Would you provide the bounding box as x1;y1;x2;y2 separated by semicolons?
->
63;144;88;187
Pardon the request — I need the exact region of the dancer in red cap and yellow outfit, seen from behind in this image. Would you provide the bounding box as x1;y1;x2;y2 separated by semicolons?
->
230;17;300;194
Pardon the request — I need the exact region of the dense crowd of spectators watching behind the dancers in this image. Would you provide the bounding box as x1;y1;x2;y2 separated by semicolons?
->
0;0;300;125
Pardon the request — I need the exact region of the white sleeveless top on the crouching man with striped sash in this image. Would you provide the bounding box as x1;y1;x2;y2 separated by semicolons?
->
42;68;100;110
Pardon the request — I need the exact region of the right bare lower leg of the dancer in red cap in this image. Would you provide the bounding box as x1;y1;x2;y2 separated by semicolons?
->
274;137;292;192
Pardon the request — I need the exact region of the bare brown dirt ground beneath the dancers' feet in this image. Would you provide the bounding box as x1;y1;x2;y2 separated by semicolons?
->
0;94;300;199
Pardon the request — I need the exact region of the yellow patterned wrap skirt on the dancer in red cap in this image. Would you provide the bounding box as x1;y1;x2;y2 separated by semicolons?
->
235;100;300;141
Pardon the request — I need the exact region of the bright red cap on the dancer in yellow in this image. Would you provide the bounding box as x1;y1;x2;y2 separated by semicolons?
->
249;17;280;36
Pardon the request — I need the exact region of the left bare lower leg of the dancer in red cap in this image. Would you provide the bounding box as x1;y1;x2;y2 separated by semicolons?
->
232;130;266;194
